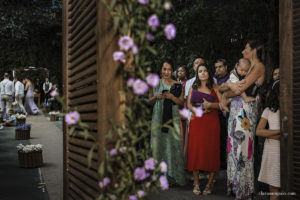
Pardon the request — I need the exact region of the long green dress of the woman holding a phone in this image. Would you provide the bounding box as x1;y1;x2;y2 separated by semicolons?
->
151;80;185;185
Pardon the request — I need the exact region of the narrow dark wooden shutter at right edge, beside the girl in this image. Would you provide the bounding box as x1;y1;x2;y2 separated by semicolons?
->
279;0;300;199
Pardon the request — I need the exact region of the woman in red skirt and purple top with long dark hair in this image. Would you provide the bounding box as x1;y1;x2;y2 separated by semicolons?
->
187;64;221;195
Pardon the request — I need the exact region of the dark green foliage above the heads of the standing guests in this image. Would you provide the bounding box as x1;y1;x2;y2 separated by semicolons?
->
151;0;278;76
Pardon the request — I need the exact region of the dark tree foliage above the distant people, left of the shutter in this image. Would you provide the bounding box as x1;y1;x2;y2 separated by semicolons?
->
0;0;62;83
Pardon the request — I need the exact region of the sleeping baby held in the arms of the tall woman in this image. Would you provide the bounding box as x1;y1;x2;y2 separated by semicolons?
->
219;58;255;112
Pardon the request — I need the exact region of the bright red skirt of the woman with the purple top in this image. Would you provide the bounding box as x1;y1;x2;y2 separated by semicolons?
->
187;90;220;172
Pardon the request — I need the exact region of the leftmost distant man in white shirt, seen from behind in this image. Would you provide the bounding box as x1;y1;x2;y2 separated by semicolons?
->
0;73;15;113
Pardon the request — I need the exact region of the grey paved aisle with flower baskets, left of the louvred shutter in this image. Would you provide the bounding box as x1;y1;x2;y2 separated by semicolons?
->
0;111;63;200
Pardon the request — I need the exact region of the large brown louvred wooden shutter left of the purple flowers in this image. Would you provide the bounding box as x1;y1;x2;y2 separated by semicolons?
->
63;0;121;200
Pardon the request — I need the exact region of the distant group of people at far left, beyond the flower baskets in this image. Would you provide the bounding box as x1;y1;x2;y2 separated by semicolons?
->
0;73;59;125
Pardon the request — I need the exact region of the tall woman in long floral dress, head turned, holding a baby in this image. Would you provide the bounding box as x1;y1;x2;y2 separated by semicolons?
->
222;41;265;199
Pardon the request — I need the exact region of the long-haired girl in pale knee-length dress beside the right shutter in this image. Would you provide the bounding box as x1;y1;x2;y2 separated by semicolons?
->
256;81;280;200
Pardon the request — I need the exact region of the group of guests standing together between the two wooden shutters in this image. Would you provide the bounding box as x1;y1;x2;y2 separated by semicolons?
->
149;40;280;199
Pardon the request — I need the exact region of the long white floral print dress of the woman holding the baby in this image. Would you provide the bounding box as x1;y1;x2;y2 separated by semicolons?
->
227;96;258;199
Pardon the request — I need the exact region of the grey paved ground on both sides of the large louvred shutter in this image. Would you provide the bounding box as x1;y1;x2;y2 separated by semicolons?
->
0;111;268;200
